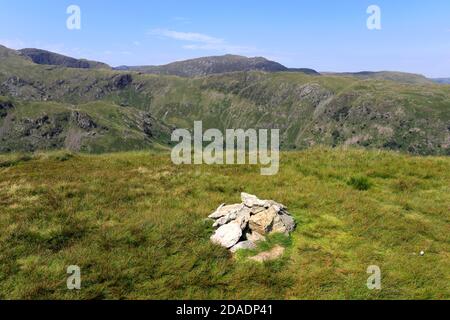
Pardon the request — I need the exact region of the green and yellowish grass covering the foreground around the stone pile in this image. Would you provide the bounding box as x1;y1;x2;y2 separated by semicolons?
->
0;148;450;299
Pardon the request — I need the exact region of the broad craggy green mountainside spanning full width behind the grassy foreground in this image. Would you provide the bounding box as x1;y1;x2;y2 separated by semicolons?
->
0;45;450;155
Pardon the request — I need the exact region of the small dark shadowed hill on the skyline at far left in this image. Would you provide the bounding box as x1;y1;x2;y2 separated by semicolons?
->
18;49;111;69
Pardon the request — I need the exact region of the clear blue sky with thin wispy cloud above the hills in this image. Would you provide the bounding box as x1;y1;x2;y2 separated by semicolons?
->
0;0;450;77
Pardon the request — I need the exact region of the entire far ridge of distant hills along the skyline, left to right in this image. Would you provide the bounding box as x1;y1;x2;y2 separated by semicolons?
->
5;45;442;84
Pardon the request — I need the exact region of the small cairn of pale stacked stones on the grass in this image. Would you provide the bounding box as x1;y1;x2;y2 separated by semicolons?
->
209;193;295;252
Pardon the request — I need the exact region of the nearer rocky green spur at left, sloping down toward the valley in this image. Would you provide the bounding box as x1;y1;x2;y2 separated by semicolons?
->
0;97;173;153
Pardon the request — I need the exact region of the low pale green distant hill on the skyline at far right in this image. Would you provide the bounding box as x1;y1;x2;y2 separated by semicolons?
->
324;71;433;84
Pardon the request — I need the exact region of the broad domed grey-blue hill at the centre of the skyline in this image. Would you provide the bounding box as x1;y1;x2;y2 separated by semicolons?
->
115;55;318;77
